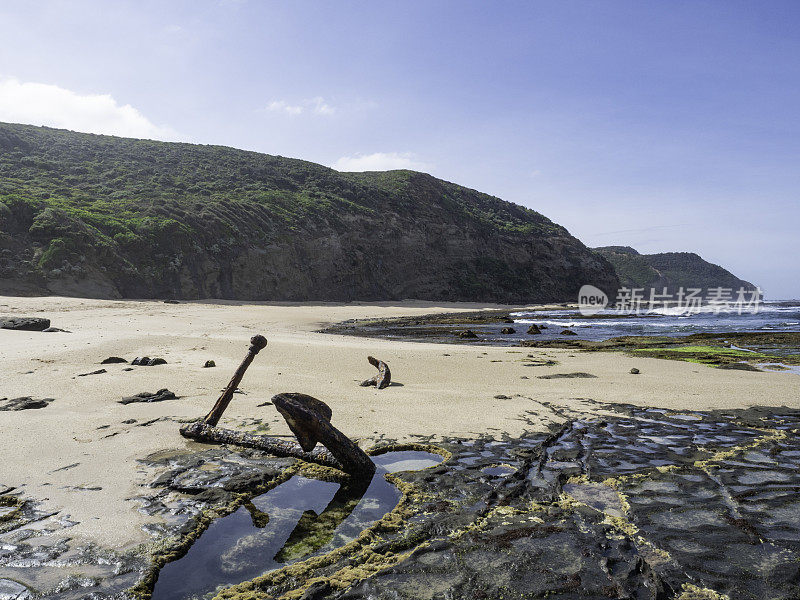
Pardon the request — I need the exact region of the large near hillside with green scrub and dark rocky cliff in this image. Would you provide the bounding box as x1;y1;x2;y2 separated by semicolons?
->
0;124;618;303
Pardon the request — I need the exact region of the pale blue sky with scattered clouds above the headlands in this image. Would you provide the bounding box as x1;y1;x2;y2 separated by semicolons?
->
0;0;800;299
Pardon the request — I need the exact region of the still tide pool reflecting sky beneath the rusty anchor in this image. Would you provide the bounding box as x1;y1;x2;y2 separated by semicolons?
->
152;451;442;600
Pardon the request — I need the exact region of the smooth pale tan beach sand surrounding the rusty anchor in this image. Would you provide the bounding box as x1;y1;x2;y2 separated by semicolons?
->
0;297;800;548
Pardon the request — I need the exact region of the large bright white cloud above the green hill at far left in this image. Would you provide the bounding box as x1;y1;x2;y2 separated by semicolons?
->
0;78;179;140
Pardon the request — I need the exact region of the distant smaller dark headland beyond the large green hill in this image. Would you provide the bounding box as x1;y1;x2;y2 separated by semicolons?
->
594;246;756;294
